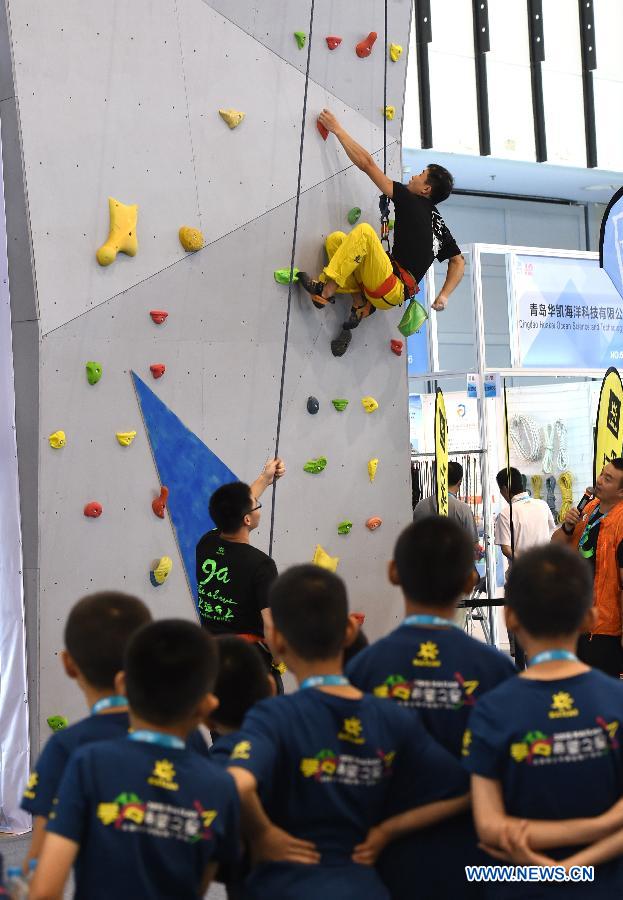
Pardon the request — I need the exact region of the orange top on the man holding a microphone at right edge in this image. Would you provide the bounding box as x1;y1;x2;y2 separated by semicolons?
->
573;500;623;636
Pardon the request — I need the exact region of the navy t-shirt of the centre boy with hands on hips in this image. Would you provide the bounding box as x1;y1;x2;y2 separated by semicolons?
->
230;689;466;900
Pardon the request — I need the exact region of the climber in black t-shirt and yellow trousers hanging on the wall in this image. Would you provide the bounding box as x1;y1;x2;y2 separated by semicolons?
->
298;109;465;356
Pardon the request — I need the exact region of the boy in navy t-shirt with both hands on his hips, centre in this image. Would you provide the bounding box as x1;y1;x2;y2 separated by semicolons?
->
225;565;467;900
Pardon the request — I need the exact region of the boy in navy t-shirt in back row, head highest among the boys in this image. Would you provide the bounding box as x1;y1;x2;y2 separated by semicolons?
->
346;516;515;900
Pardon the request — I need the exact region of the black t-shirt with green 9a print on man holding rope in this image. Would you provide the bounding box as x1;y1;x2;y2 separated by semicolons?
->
196;530;277;637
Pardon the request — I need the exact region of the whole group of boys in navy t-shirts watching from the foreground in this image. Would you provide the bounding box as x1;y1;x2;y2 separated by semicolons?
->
9;517;623;900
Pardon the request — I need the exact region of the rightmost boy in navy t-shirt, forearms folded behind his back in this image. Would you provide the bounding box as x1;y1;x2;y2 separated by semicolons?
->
463;544;623;898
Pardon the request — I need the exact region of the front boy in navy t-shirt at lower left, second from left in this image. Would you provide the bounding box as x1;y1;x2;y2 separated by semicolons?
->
29;619;239;900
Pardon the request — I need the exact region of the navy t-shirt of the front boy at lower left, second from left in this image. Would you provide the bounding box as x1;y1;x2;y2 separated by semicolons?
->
48;738;240;900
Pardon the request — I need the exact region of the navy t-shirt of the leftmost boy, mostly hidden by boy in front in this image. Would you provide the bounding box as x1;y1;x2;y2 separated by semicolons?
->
21;712;130;819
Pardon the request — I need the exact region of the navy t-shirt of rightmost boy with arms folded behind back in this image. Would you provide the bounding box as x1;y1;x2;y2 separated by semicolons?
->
463;669;623;897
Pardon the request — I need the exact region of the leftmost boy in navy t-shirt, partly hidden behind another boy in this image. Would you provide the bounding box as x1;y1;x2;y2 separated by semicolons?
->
21;591;151;872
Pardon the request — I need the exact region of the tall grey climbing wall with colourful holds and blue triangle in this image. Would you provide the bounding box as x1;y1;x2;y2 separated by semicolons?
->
7;0;411;737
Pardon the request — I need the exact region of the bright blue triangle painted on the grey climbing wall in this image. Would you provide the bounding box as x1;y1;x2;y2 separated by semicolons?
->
132;372;239;603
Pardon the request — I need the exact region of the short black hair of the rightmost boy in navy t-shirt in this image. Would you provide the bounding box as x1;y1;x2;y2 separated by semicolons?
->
505;544;593;638
